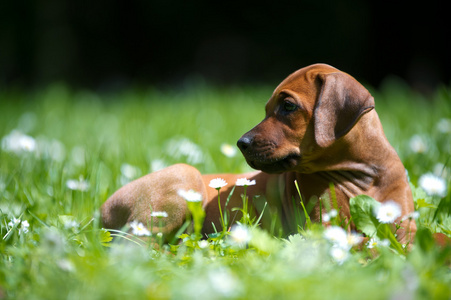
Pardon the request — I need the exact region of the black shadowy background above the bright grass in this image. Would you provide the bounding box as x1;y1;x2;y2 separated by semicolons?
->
0;0;451;92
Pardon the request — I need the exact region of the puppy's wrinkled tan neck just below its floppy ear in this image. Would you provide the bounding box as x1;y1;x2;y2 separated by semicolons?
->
313;110;405;197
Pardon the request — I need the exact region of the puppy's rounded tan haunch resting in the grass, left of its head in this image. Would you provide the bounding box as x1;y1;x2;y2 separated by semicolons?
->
101;164;207;240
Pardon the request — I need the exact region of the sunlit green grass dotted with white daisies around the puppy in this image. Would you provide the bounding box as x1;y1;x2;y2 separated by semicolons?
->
0;80;451;299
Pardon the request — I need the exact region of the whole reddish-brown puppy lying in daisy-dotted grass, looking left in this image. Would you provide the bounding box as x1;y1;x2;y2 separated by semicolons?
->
102;64;416;242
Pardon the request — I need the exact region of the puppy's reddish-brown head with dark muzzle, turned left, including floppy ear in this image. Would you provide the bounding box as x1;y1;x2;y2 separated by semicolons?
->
237;64;374;173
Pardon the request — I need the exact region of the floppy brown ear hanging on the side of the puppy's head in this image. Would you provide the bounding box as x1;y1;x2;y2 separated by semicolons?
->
314;72;374;148
